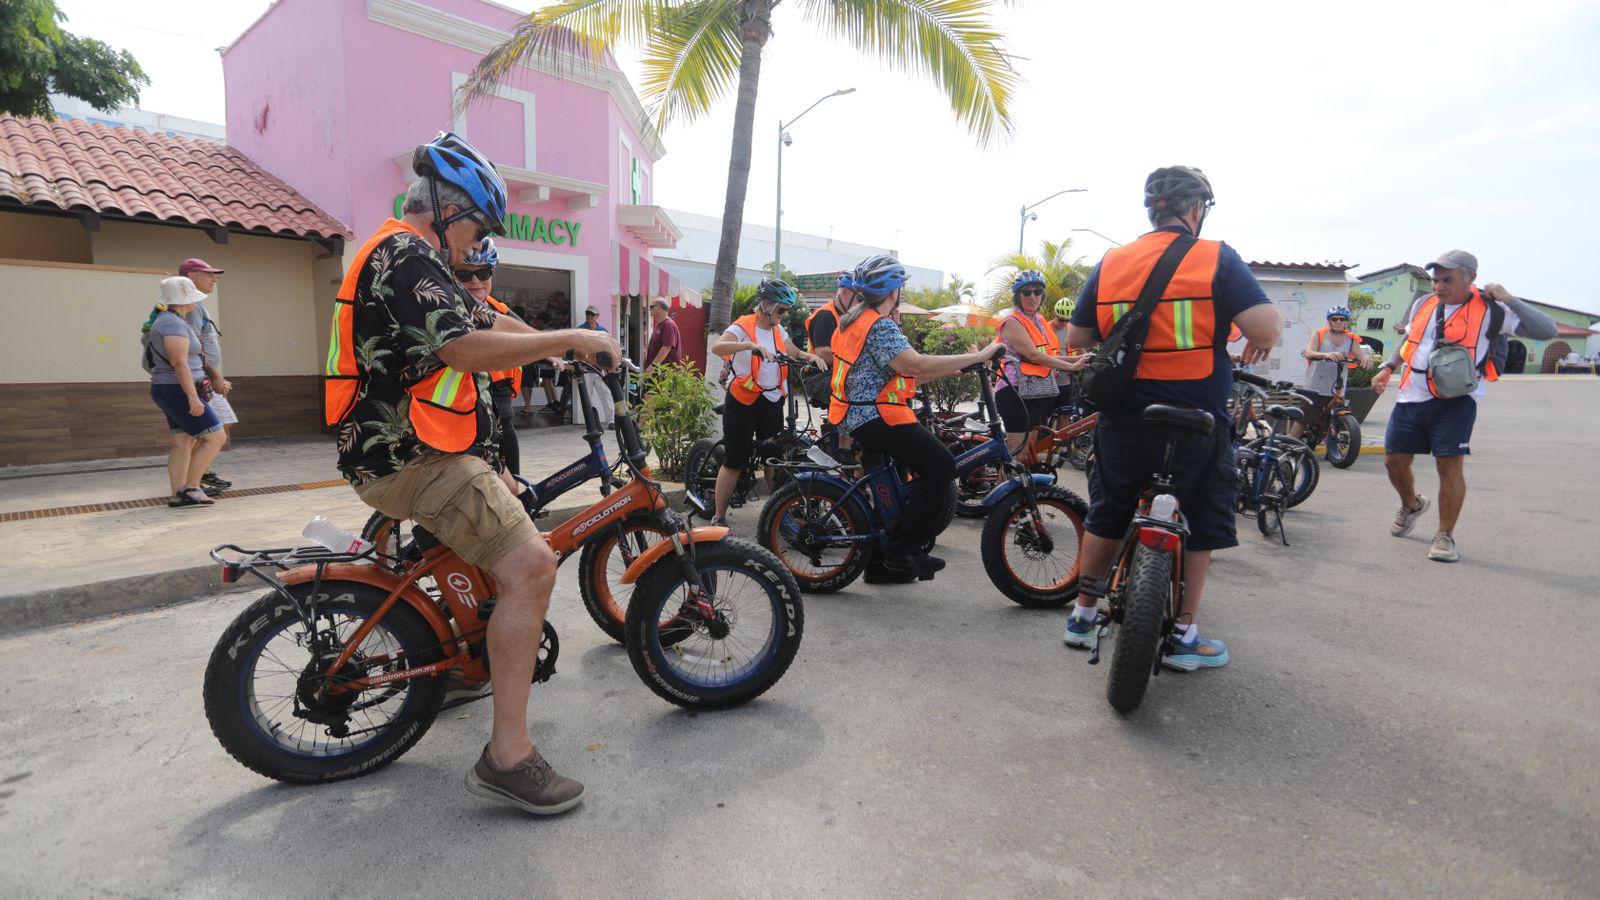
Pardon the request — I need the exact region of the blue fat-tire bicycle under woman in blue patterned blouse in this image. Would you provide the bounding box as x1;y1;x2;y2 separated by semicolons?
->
757;355;1088;609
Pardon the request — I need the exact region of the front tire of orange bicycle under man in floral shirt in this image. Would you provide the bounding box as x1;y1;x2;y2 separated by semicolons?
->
626;538;805;709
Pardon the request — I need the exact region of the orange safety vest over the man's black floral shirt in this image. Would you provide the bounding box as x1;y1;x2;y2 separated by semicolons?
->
322;219;478;453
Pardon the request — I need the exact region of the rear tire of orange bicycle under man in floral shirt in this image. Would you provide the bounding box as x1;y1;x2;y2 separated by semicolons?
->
203;581;445;783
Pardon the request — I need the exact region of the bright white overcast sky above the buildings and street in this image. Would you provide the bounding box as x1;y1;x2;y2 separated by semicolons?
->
59;0;1600;312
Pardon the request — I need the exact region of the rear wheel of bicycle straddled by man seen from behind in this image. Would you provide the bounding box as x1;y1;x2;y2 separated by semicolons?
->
1106;546;1173;713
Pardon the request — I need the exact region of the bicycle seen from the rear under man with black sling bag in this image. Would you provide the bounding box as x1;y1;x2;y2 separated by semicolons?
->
1088;404;1214;713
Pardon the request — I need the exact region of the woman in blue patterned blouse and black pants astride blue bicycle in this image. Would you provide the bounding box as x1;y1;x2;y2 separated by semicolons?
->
827;253;1000;583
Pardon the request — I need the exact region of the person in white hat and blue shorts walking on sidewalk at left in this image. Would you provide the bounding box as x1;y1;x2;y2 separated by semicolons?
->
144;275;224;508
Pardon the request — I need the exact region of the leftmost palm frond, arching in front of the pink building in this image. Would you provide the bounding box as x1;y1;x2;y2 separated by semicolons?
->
456;0;677;112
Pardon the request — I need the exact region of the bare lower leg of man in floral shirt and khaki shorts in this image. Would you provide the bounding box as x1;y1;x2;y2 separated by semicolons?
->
488;538;555;769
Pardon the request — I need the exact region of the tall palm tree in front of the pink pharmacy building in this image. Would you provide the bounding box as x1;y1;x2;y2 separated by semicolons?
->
458;0;1018;333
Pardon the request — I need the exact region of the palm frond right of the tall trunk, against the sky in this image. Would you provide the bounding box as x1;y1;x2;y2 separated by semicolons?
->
802;0;1018;144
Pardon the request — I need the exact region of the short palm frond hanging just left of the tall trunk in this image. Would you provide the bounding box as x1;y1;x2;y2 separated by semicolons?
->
640;0;744;130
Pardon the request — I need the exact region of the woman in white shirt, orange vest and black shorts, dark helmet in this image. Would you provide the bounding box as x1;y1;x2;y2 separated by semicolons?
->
710;279;827;525
